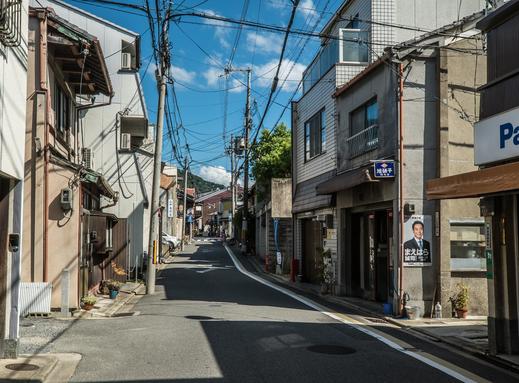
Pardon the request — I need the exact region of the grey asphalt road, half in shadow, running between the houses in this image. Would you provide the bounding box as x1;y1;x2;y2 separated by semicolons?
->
38;238;517;383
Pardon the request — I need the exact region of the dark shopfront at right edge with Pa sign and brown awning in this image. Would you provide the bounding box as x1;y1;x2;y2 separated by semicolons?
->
427;0;519;355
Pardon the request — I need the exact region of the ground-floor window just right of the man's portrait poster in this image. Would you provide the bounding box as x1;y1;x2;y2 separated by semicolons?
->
450;222;486;271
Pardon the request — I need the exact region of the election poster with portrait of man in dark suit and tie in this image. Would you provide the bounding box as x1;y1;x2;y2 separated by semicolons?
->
403;215;432;266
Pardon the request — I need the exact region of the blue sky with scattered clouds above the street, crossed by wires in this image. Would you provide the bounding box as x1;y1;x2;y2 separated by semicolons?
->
66;0;342;184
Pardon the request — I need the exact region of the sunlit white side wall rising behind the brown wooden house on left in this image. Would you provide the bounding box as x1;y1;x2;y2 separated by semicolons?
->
30;0;153;267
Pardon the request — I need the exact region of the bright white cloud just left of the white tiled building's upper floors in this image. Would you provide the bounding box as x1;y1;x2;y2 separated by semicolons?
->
254;59;306;92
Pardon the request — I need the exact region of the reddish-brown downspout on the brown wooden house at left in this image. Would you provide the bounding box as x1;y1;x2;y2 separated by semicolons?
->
38;11;50;282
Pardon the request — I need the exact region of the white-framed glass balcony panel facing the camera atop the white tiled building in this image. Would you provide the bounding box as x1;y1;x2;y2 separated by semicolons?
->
339;14;369;63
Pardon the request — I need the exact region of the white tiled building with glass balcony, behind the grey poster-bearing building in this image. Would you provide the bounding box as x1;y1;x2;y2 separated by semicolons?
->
292;0;485;293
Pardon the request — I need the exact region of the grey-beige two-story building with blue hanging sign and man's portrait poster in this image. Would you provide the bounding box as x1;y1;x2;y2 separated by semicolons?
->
328;12;487;317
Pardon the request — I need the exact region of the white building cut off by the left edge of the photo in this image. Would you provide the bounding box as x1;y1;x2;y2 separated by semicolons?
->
0;0;28;358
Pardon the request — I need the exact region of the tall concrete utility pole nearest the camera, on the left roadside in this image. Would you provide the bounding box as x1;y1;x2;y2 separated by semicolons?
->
146;4;169;294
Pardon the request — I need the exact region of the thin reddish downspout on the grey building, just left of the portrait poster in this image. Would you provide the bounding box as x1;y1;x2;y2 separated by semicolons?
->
398;63;404;315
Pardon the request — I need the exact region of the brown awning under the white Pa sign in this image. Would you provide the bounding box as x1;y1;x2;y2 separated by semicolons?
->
426;162;519;200
